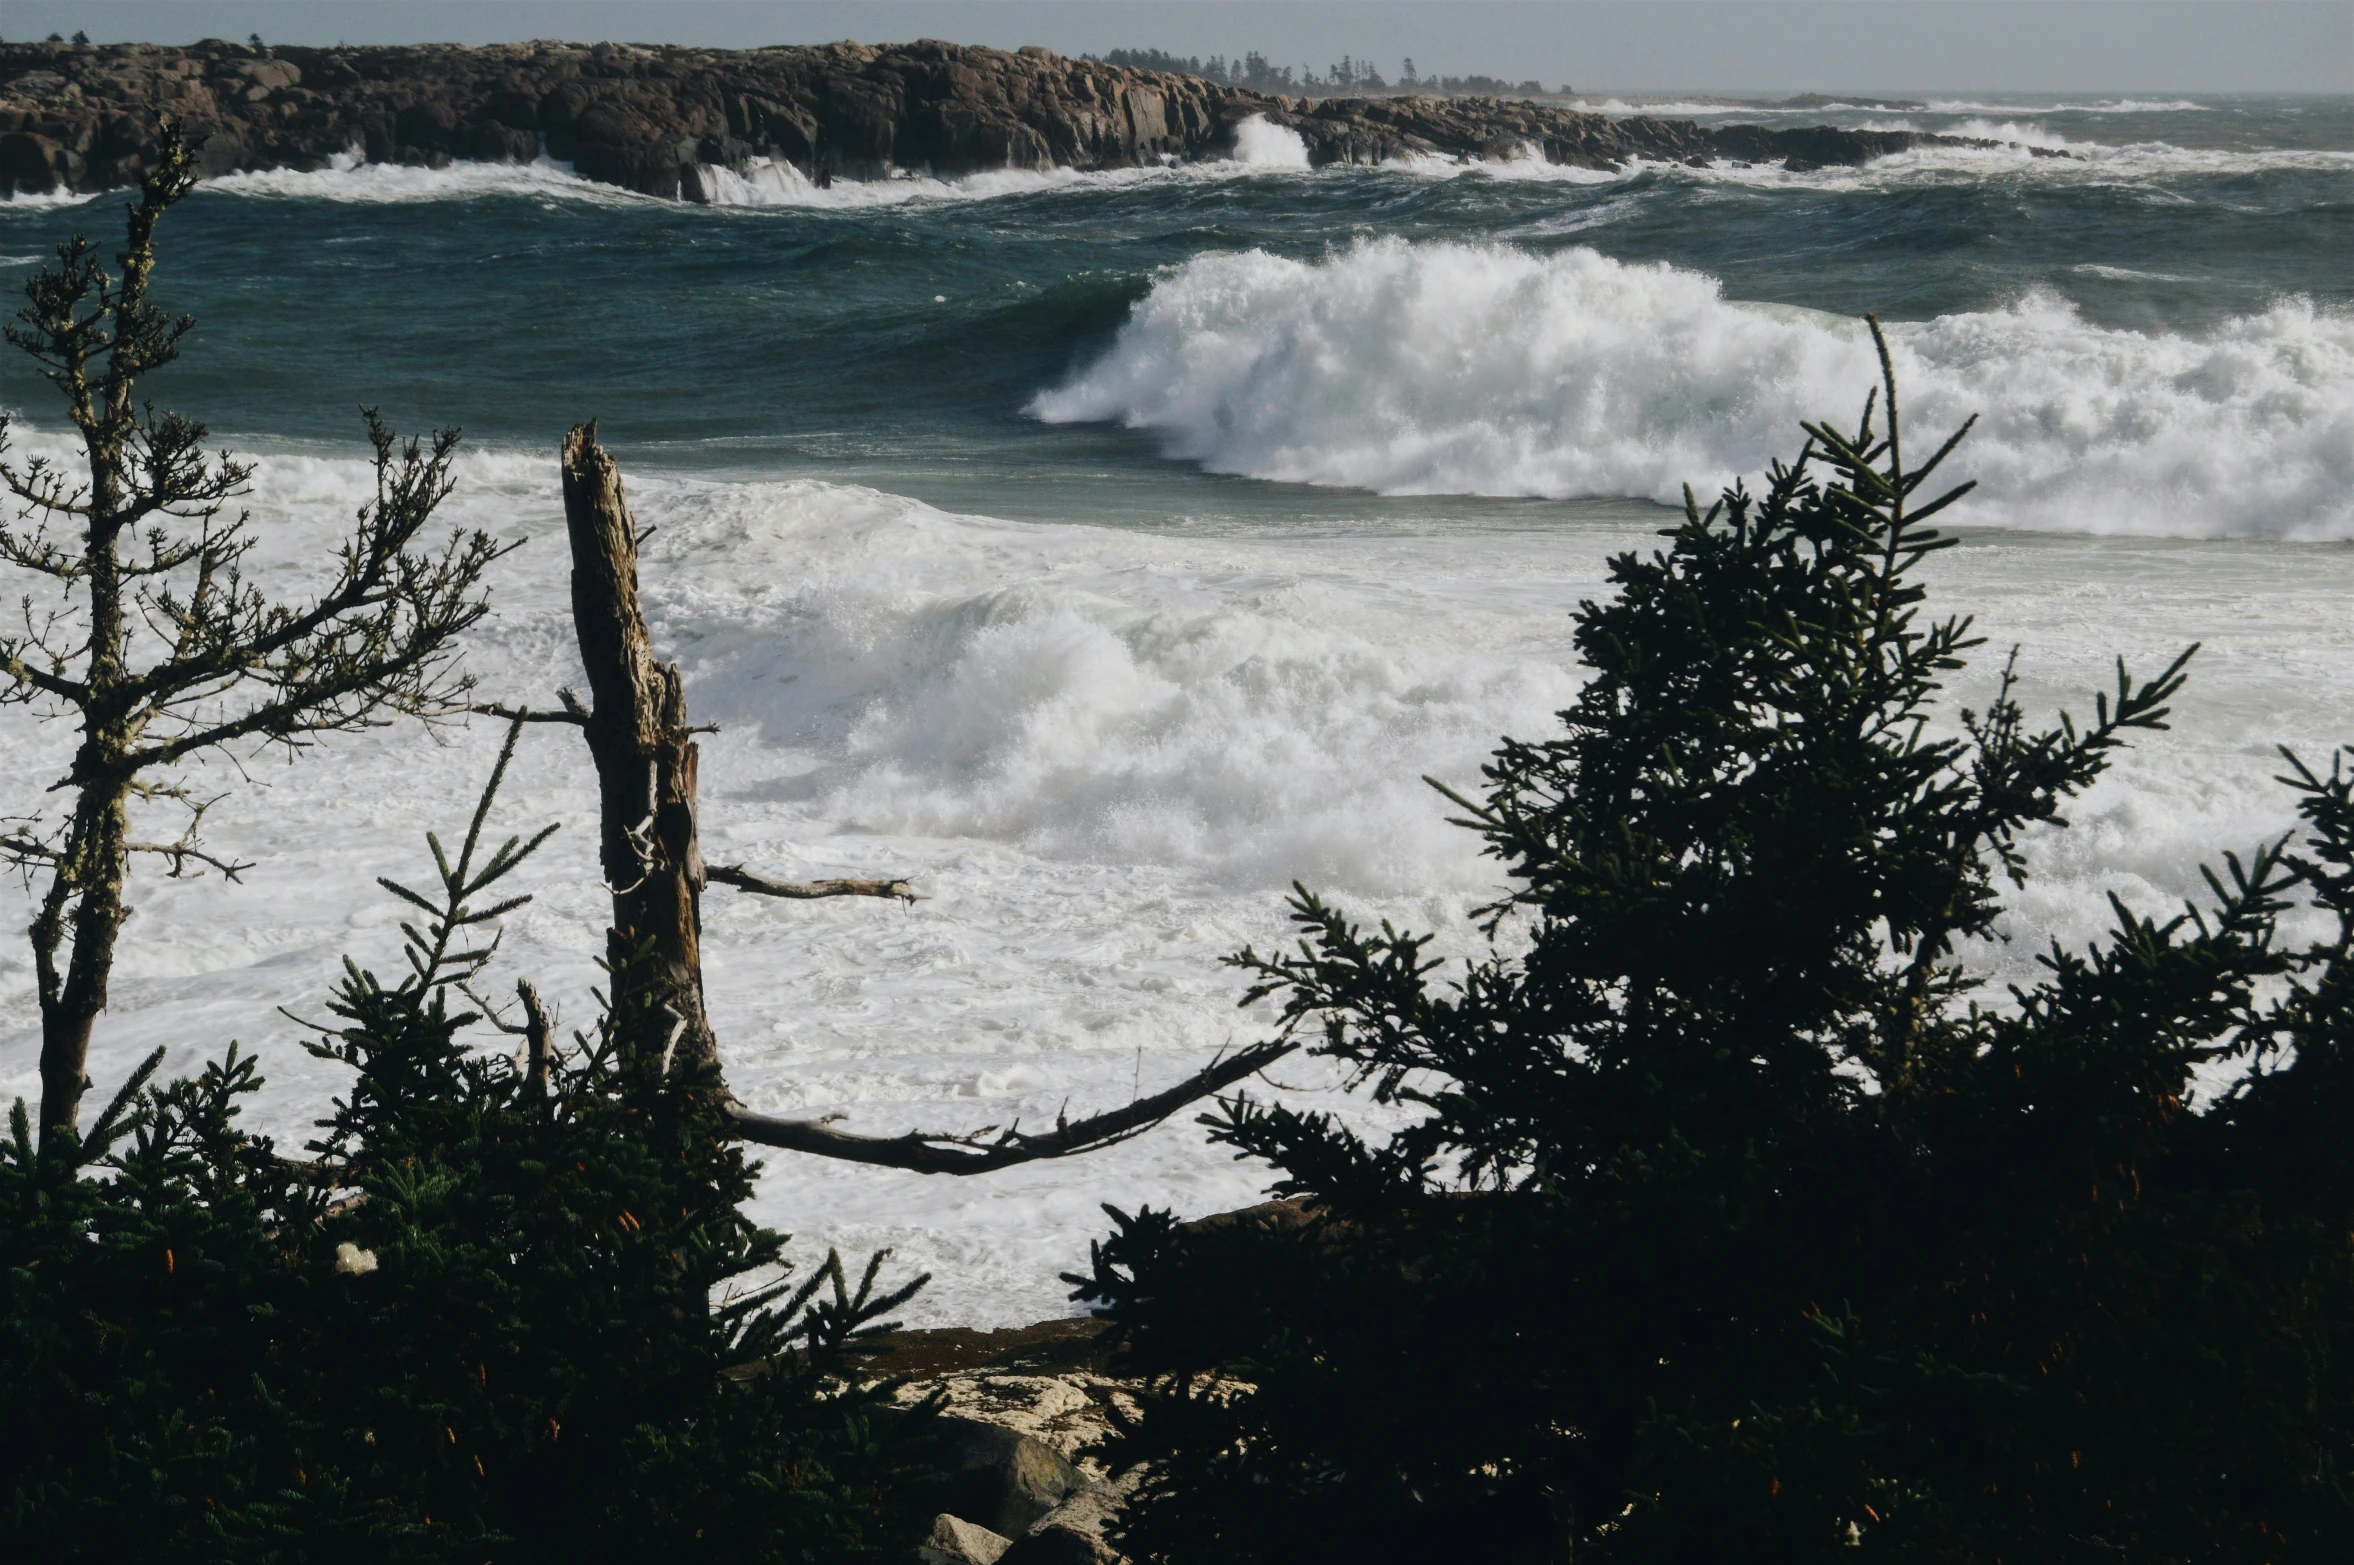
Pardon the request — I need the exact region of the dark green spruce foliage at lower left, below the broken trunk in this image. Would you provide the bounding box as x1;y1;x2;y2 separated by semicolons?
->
0;724;920;1565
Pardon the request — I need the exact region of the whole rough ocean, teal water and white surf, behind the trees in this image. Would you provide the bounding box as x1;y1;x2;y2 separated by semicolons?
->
0;96;2354;1325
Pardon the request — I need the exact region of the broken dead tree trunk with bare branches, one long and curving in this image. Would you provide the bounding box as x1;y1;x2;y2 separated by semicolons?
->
543;424;1297;1174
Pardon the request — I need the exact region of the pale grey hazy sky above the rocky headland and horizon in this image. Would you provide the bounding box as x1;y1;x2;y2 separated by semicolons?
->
18;0;2354;92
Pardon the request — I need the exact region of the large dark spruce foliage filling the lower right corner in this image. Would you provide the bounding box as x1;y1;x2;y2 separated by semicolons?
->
1073;327;2354;1563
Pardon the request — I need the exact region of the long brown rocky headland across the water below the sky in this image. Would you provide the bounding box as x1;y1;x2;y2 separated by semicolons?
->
0;40;2043;202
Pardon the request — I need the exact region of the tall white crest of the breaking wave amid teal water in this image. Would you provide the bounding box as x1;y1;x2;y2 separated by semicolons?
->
1031;240;2354;539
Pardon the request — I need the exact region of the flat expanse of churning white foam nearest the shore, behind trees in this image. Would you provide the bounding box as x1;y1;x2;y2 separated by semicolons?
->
0;404;2354;1325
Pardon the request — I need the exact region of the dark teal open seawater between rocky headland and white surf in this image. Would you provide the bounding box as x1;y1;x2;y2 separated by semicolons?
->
0;99;2354;527
